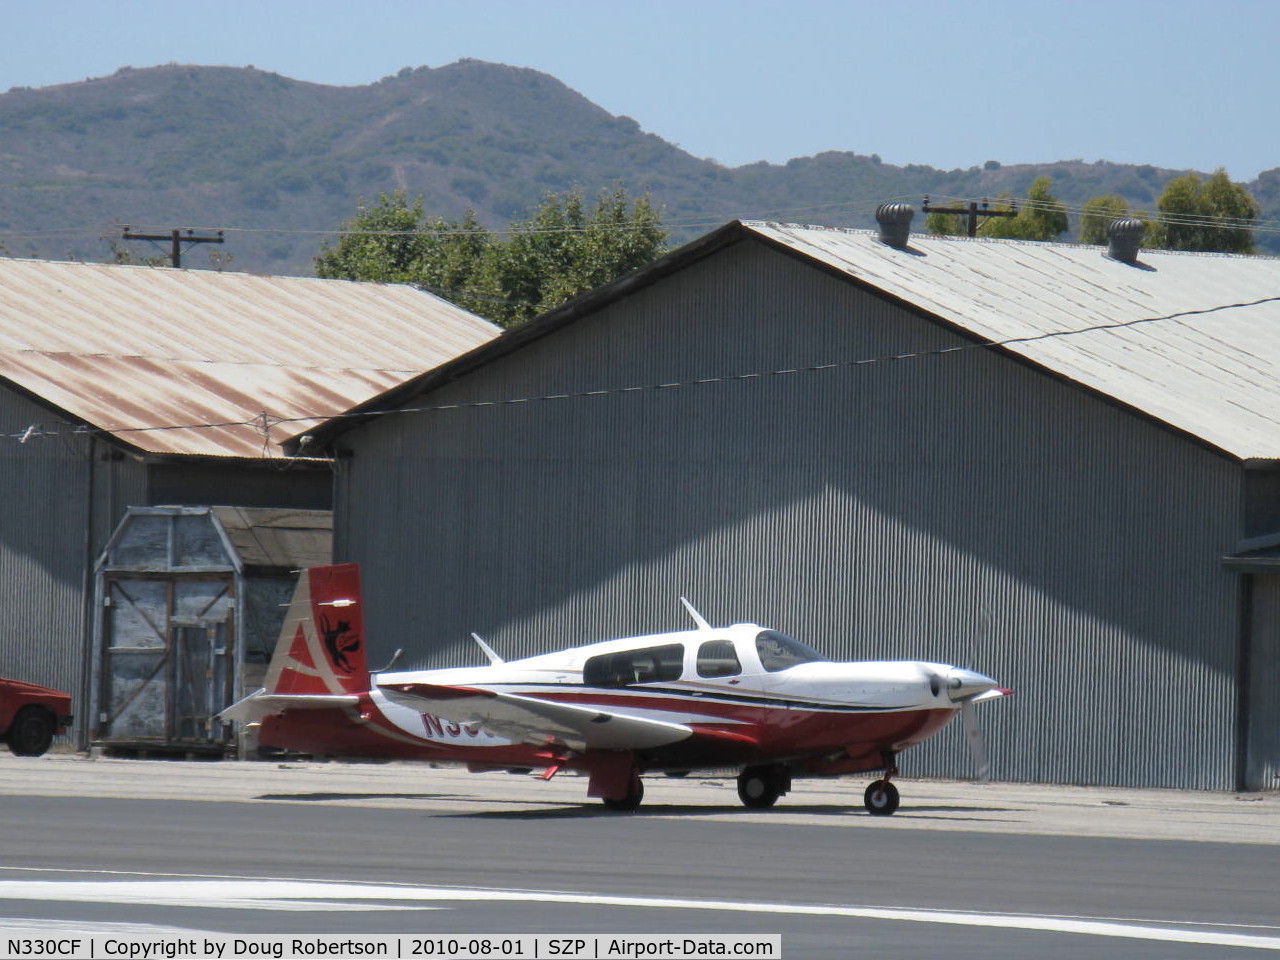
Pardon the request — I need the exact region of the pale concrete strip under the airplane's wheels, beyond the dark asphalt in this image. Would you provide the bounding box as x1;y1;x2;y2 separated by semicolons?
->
0;754;1280;845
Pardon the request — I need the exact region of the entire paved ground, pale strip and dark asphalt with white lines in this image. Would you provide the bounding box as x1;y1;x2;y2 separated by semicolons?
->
0;755;1280;960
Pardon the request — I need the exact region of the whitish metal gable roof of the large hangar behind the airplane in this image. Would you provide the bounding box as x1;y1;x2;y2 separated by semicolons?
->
288;223;1280;460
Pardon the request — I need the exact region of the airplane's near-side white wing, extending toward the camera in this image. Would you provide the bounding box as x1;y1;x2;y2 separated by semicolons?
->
379;684;694;750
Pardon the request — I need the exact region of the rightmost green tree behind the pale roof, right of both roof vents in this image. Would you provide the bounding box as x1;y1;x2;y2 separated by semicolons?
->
1147;168;1258;253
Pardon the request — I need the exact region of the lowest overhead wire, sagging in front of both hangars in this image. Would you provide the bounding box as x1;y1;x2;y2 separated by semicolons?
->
0;296;1280;451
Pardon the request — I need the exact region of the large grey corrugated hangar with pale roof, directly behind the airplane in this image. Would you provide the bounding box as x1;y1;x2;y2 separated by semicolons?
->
307;223;1280;788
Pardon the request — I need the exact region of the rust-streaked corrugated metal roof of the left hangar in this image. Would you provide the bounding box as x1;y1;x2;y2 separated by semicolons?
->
0;259;499;457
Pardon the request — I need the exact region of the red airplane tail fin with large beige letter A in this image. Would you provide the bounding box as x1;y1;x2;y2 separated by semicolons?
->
266;563;369;694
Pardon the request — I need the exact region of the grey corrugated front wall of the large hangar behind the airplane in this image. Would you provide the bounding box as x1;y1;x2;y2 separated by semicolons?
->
335;239;1259;788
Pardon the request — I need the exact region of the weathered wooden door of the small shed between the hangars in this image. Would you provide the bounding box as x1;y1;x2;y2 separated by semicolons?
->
96;573;234;748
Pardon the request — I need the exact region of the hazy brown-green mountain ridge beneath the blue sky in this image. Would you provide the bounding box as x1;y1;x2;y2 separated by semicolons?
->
0;60;1280;274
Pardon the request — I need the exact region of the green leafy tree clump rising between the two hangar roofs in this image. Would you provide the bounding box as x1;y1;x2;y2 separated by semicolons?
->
316;188;667;326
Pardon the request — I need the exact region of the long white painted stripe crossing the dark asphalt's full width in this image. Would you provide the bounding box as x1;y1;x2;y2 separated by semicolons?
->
0;878;1280;950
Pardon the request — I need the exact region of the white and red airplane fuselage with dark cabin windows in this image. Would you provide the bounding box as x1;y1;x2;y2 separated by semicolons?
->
260;623;997;774
